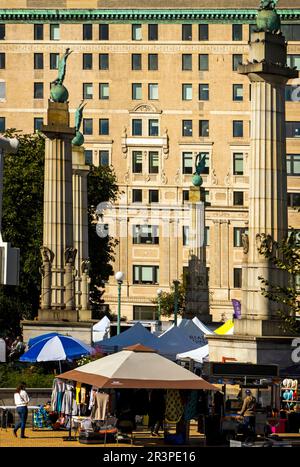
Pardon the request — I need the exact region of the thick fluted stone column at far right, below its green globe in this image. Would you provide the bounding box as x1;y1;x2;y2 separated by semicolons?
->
235;31;298;335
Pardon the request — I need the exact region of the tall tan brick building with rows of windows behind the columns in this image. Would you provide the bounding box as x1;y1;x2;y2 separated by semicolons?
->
0;0;300;321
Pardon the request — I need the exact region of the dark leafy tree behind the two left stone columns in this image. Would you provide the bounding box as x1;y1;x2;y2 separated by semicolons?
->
0;129;118;337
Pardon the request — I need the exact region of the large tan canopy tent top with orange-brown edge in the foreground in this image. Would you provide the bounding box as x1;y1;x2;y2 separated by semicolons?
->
59;344;218;391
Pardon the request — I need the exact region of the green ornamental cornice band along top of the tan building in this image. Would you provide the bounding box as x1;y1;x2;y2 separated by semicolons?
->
0;8;300;23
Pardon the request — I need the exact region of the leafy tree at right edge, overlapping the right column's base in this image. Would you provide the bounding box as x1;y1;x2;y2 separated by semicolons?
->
259;229;300;334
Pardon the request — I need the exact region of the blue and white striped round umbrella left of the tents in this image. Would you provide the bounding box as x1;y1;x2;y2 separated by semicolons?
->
20;334;94;362
